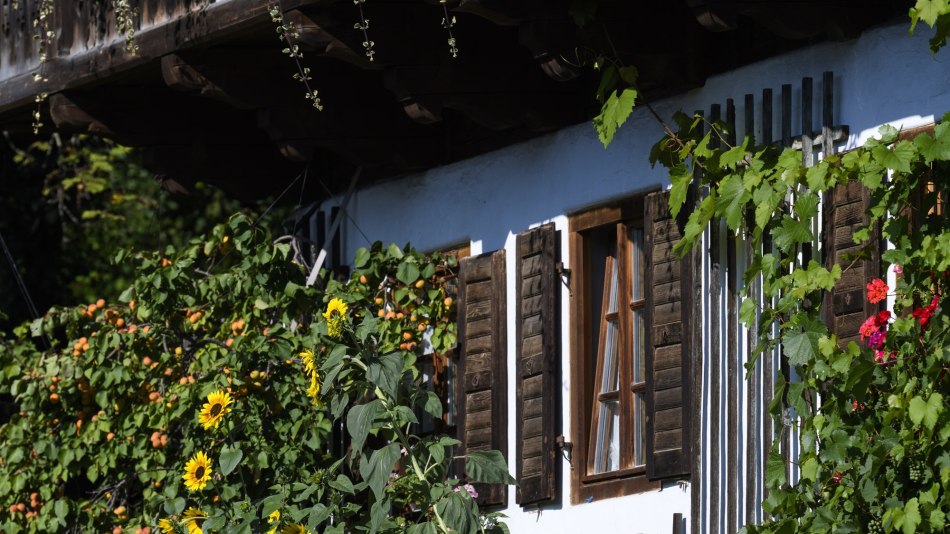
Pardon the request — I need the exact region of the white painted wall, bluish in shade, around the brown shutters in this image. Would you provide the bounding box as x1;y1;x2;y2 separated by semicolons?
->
324;21;950;534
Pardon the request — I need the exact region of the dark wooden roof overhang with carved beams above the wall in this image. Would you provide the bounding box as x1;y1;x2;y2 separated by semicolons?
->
0;0;906;198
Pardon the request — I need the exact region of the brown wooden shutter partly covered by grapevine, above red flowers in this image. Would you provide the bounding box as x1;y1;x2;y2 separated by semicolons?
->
822;182;881;347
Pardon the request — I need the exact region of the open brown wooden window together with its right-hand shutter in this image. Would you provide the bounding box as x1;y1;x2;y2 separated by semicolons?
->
570;193;692;502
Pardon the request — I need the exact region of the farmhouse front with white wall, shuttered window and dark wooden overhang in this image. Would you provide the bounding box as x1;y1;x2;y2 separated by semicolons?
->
0;0;950;534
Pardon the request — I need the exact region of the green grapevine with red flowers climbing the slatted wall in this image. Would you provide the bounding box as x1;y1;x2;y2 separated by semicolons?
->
652;115;950;533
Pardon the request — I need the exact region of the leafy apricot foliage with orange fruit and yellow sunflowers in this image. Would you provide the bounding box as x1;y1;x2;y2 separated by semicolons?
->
0;215;512;534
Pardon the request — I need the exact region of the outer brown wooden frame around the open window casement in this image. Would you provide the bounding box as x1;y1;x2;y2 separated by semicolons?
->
569;195;660;504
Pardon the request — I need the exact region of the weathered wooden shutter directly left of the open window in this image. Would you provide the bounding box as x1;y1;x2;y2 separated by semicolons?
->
515;224;561;506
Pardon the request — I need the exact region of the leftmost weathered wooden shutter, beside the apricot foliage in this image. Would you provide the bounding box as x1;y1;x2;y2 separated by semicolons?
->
457;250;508;506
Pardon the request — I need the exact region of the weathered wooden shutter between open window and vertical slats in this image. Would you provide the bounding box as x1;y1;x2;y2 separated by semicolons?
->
643;192;694;479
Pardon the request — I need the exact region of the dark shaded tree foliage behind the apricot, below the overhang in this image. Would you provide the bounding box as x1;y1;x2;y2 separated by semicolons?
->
0;135;240;328
